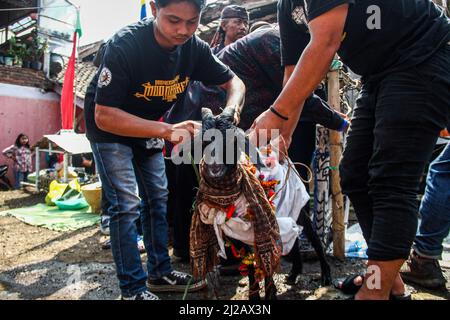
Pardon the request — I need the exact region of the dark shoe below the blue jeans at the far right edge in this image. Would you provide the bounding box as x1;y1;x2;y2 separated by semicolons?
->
400;251;446;289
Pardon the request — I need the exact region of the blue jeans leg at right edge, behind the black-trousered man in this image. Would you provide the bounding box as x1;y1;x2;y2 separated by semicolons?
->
413;144;450;259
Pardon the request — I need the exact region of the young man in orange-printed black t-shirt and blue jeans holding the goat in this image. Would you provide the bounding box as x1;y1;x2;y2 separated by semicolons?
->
85;0;245;300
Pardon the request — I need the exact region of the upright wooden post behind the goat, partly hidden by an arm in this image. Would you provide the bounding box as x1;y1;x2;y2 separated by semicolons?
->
328;70;345;260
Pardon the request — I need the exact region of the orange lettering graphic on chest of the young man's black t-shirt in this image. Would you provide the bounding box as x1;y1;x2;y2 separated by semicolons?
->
135;75;190;102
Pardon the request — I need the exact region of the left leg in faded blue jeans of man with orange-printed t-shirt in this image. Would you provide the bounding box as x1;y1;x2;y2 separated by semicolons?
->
93;143;147;297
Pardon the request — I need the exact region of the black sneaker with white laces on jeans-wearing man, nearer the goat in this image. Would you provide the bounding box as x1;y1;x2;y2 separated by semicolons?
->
147;271;206;292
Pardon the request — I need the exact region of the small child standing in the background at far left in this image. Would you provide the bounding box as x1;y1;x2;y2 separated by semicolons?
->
3;133;32;189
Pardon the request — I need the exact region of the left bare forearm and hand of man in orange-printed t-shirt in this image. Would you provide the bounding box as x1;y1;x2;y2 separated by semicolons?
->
95;104;199;143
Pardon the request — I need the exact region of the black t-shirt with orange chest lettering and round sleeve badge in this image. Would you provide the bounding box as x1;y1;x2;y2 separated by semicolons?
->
85;19;233;149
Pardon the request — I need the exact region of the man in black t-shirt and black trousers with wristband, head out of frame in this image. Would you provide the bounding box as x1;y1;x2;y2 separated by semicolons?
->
253;0;450;299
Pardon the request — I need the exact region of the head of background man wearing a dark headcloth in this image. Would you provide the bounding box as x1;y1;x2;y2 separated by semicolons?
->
211;5;250;54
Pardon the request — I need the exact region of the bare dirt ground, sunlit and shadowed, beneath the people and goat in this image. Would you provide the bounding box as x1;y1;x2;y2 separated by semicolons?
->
0;190;450;300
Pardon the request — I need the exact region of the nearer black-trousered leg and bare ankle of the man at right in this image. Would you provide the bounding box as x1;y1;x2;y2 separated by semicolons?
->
356;45;450;299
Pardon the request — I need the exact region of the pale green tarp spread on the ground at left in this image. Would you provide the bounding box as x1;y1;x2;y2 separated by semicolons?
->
0;204;100;231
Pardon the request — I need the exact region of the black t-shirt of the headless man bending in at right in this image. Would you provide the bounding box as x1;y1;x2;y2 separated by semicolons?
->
279;0;450;79
